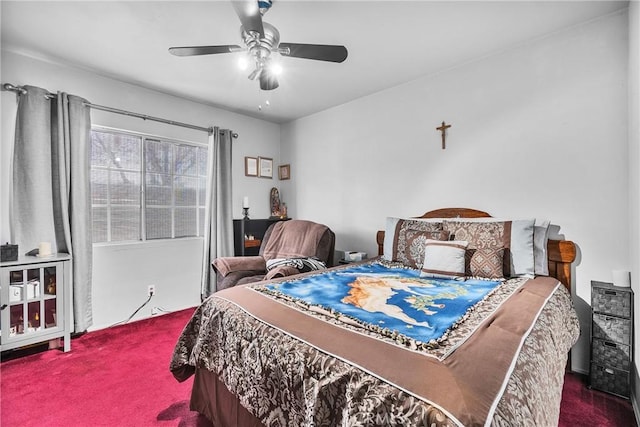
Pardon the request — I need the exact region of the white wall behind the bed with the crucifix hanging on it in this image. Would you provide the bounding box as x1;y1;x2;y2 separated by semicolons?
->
282;11;629;372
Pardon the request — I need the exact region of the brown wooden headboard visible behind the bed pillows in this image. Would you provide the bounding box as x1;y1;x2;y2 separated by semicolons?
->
376;208;576;292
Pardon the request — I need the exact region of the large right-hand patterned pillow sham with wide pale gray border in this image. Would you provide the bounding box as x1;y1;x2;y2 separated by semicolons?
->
443;218;535;277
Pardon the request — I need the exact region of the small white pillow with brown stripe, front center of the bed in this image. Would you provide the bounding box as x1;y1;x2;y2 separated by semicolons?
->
420;239;468;280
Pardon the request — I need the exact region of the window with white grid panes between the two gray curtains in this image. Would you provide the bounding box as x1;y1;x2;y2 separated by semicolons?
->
91;129;207;242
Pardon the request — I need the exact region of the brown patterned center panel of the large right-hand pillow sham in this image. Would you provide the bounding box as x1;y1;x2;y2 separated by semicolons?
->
443;220;511;277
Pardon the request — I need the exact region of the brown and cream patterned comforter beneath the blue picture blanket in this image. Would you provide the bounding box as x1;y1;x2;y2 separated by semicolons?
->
171;260;579;426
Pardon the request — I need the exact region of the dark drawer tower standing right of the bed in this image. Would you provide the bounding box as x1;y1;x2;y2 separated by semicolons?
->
589;281;633;399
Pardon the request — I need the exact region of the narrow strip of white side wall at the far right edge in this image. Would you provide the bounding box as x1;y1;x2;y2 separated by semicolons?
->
629;1;640;418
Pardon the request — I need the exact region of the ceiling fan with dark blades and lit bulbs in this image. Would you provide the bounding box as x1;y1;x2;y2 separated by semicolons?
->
169;0;347;90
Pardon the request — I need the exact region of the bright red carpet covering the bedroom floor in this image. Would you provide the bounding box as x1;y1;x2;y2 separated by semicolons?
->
0;309;636;427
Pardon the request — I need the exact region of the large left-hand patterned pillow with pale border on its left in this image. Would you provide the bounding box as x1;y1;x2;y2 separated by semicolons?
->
383;218;449;268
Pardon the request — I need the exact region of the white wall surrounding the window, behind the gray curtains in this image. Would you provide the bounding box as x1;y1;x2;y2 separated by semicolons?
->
0;50;280;329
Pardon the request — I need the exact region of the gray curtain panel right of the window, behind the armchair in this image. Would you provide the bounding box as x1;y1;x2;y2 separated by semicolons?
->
200;127;233;299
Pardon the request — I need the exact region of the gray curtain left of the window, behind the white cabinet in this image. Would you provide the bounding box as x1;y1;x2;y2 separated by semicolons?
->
11;86;93;332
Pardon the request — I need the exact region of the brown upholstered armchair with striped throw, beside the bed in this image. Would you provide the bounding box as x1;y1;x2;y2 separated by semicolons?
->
213;219;335;291
